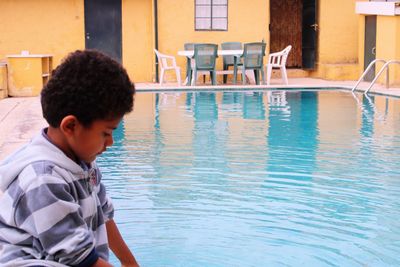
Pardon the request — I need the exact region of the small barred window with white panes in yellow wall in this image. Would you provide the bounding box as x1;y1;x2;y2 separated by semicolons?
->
195;0;228;31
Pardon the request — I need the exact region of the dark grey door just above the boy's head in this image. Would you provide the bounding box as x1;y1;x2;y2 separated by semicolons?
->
85;0;122;62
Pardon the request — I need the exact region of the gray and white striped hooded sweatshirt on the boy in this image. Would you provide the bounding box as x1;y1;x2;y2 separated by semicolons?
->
0;131;114;266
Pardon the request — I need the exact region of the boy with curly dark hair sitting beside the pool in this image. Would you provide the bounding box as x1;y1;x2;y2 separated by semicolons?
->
0;50;138;266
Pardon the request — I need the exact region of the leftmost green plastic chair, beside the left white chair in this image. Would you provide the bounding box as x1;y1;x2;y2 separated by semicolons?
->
192;44;218;85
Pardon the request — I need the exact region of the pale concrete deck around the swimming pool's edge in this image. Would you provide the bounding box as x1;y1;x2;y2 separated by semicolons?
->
0;78;400;160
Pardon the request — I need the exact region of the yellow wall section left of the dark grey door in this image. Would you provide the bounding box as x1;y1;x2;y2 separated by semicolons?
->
0;0;85;66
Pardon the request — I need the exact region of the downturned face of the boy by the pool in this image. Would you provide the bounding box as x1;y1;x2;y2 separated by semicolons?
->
69;117;122;163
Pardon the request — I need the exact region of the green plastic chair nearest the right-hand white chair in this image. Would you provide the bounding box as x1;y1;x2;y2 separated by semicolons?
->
233;42;266;84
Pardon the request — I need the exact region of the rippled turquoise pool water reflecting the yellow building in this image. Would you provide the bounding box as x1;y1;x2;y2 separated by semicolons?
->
98;90;400;267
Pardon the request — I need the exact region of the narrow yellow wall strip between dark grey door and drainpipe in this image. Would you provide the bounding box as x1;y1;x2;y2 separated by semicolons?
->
122;0;154;82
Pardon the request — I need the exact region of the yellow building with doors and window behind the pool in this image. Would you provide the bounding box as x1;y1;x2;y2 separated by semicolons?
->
0;0;400;90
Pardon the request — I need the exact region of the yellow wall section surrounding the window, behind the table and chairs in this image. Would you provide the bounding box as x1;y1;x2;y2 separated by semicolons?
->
153;0;269;81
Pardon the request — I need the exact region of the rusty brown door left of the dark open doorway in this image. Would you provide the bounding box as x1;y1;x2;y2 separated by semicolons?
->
270;0;303;68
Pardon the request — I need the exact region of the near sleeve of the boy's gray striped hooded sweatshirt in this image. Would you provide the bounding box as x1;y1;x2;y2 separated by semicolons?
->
14;174;94;266
